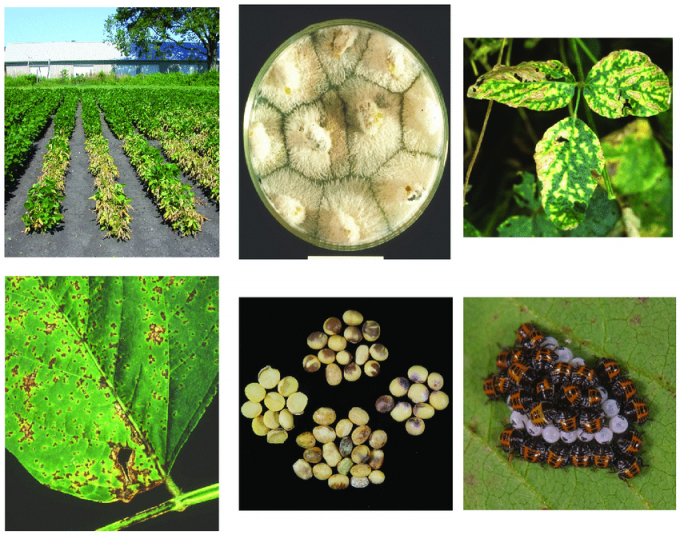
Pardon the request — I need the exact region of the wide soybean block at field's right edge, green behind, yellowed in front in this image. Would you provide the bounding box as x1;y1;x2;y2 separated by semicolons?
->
117;88;220;202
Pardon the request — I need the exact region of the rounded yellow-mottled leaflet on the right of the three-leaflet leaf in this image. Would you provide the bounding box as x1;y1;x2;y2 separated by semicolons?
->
583;50;671;119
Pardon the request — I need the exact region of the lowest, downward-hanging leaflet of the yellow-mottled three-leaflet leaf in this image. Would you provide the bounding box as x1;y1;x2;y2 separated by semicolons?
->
534;117;604;230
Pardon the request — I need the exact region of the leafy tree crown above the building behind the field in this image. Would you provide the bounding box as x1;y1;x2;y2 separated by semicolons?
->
105;7;220;70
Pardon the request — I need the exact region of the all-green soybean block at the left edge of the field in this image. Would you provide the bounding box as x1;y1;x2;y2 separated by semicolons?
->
5;89;63;184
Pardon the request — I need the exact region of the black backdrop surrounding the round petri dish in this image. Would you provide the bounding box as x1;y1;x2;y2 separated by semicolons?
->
239;5;451;259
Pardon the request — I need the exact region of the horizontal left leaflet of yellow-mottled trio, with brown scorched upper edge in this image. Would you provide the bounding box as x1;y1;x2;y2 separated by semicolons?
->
467;60;576;111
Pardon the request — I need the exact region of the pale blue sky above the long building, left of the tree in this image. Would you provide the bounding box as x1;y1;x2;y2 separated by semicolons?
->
5;7;116;45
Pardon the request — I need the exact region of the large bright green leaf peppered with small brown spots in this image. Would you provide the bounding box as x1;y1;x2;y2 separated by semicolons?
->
5;277;218;502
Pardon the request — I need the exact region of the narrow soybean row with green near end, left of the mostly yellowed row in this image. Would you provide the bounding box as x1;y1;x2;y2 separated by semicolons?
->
21;91;80;233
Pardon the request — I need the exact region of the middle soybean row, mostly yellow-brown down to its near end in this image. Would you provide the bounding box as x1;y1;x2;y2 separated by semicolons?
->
81;91;132;240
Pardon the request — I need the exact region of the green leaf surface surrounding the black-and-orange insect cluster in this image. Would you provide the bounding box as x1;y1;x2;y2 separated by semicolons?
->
462;298;676;510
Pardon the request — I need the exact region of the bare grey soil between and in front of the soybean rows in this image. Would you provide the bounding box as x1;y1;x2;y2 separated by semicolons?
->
5;104;220;257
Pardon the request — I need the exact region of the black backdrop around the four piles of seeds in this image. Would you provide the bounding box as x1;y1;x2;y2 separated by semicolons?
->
239;298;453;510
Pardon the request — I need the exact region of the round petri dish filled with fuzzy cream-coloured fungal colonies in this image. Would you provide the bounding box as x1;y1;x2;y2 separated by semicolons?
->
244;19;448;250
